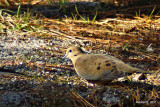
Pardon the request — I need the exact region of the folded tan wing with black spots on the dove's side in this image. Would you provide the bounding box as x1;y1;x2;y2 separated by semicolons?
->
74;54;123;80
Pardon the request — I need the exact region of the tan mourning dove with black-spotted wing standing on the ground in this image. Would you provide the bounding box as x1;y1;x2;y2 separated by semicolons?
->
65;47;152;83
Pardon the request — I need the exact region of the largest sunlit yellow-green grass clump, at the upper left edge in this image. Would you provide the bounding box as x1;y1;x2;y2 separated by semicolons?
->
0;4;43;31
